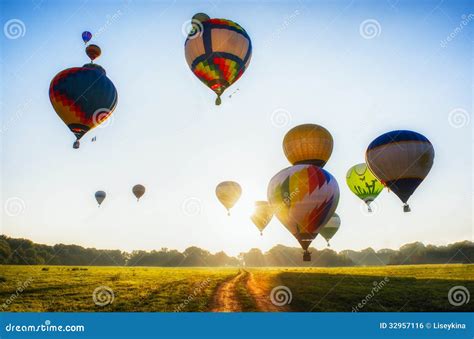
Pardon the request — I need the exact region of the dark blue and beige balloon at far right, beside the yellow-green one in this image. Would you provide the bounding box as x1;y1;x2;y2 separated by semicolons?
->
365;130;434;212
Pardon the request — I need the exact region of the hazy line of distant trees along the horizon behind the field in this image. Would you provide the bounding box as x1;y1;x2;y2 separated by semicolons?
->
0;235;474;267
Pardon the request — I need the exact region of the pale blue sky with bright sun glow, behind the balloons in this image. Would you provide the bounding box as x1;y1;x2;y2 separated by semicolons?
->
0;0;474;255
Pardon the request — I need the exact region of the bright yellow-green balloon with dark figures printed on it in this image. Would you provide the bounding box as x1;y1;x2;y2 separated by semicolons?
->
346;163;384;212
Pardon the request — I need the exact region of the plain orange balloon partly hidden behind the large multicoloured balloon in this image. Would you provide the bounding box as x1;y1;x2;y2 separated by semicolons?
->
283;124;333;167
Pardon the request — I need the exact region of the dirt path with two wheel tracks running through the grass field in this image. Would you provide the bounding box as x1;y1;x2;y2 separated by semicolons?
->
211;269;290;312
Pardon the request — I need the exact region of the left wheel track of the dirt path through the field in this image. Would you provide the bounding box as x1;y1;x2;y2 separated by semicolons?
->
211;270;248;312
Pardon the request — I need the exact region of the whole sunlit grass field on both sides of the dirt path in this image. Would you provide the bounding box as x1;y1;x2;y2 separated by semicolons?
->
0;265;474;312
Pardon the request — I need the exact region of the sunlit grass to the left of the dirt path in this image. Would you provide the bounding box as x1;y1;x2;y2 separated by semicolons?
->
0;266;238;312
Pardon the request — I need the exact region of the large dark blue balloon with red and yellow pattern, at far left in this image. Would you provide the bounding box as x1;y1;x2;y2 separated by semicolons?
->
49;64;117;148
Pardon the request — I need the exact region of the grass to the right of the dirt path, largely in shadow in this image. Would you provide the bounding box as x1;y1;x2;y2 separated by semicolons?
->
267;265;474;312
